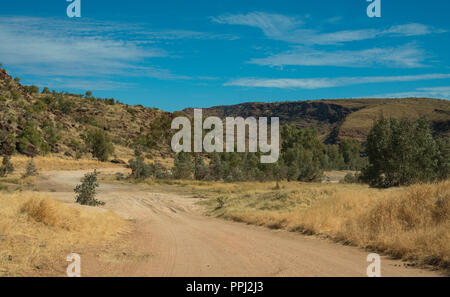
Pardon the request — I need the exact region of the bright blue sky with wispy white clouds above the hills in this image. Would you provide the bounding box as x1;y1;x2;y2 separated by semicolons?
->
0;0;450;111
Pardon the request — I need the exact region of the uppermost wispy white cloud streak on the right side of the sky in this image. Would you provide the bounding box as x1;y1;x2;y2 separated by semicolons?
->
212;12;445;45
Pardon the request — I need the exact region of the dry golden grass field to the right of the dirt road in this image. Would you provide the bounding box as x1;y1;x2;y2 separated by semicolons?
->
180;181;450;269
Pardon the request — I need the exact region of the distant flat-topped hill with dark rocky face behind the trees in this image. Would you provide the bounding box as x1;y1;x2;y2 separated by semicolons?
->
184;98;450;143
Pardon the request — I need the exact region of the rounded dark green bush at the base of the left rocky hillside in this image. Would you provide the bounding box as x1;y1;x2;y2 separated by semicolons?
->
82;129;114;162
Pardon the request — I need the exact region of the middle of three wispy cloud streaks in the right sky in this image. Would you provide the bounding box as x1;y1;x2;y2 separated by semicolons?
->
250;43;426;68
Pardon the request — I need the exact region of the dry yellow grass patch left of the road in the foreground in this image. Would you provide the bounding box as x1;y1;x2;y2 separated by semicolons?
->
0;193;127;276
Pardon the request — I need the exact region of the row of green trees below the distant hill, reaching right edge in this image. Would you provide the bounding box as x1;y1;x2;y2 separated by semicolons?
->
125;117;450;187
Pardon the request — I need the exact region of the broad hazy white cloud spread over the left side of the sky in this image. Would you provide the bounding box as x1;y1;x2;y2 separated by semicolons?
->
0;16;235;85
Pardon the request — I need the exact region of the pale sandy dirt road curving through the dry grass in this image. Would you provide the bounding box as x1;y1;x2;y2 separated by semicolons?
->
39;169;439;276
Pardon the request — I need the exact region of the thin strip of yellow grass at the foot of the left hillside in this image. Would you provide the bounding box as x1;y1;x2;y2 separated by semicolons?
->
11;155;123;172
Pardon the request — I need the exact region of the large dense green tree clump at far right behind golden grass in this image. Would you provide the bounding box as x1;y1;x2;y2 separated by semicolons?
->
362;117;448;187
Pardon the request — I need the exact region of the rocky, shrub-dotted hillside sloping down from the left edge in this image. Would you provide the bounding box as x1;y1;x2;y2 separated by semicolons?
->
0;69;171;157
